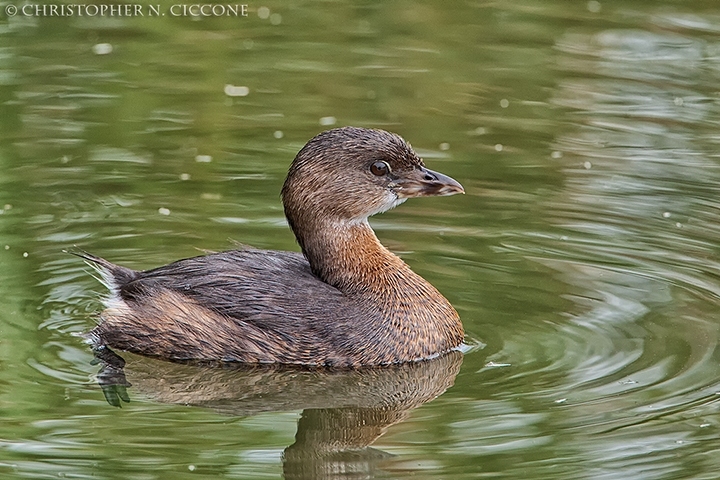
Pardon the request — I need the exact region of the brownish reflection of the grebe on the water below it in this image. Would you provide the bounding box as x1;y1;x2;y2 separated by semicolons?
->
91;349;462;479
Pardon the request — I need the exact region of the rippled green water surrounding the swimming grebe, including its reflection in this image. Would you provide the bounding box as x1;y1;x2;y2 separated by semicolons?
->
0;0;720;480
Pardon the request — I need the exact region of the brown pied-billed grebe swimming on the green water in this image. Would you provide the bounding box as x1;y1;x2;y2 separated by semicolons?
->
80;127;464;366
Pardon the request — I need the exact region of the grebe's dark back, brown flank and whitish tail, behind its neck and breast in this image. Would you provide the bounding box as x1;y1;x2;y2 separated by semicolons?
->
85;249;367;365
